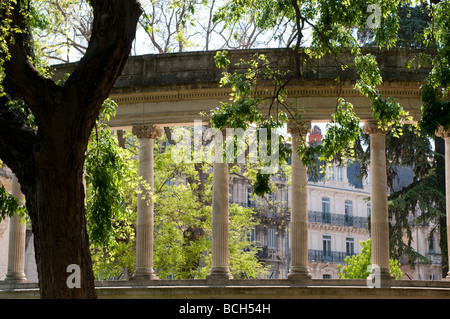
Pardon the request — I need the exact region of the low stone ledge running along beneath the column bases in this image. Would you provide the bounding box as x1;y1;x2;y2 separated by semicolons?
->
0;279;450;299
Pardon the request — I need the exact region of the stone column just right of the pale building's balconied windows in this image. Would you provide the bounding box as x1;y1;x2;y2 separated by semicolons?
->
364;120;393;286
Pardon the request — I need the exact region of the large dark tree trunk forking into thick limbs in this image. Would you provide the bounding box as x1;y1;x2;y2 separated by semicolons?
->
0;0;141;299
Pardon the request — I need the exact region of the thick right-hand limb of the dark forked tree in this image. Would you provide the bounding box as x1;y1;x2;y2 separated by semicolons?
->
65;0;142;117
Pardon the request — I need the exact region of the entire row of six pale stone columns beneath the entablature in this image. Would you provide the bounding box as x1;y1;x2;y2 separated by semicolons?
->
6;121;450;286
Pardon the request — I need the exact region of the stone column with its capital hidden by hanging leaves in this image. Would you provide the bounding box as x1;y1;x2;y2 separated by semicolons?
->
208;132;233;280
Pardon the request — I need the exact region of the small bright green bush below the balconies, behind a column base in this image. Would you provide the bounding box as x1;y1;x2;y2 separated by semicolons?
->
338;239;402;279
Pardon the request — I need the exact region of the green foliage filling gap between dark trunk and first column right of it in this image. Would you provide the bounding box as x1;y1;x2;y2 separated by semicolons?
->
86;125;140;280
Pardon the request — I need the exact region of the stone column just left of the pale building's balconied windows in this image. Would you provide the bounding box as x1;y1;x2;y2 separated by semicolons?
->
288;122;311;281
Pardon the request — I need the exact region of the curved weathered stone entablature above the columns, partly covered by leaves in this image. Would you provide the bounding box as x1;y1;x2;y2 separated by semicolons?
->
55;48;430;128
